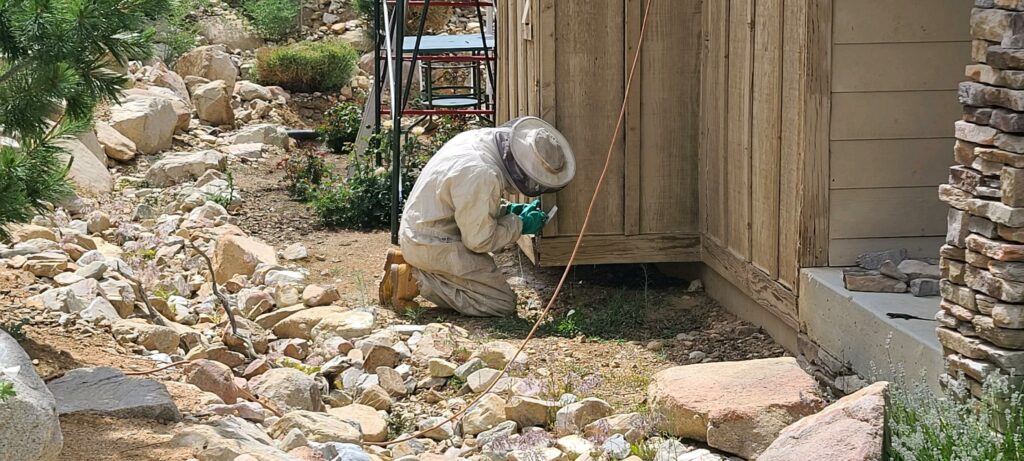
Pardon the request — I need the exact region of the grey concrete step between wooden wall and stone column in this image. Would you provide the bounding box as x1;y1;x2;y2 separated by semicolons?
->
799;267;943;390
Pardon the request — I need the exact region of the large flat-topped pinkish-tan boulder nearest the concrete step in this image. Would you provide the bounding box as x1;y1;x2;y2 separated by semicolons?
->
647;358;824;458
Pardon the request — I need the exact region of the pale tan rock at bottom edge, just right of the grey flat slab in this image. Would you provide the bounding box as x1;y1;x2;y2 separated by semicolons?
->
170;416;295;461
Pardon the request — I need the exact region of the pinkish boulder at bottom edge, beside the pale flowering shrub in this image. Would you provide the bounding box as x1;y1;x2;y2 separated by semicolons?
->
758;381;889;461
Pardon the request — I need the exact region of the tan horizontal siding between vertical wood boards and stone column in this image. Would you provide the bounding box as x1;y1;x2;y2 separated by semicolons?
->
828;0;973;265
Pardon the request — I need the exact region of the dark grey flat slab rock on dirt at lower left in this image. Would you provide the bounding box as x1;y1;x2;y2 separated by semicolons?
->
48;367;181;422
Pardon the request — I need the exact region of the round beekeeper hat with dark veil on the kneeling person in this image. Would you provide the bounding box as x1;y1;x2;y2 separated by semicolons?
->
495;117;575;197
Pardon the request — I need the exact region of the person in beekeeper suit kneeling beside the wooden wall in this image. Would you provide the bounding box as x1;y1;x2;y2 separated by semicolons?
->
380;117;575;317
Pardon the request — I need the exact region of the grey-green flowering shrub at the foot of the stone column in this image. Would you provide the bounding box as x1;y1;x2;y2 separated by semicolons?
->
886;373;1024;461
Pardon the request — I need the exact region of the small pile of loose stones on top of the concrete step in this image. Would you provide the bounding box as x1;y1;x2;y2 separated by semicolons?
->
843;249;940;296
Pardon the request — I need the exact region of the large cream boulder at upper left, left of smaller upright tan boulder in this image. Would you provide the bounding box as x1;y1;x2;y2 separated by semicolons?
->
110;94;177;154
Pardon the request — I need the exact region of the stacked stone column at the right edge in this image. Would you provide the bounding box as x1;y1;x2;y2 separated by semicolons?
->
936;0;1024;395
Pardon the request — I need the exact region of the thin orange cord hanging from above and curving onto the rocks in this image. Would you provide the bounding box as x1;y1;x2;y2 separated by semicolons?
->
362;0;654;447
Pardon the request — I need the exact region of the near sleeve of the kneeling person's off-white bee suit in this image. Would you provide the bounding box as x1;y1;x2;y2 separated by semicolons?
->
451;171;522;253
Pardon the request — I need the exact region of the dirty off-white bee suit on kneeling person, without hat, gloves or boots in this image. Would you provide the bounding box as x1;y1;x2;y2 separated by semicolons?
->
398;128;522;317
